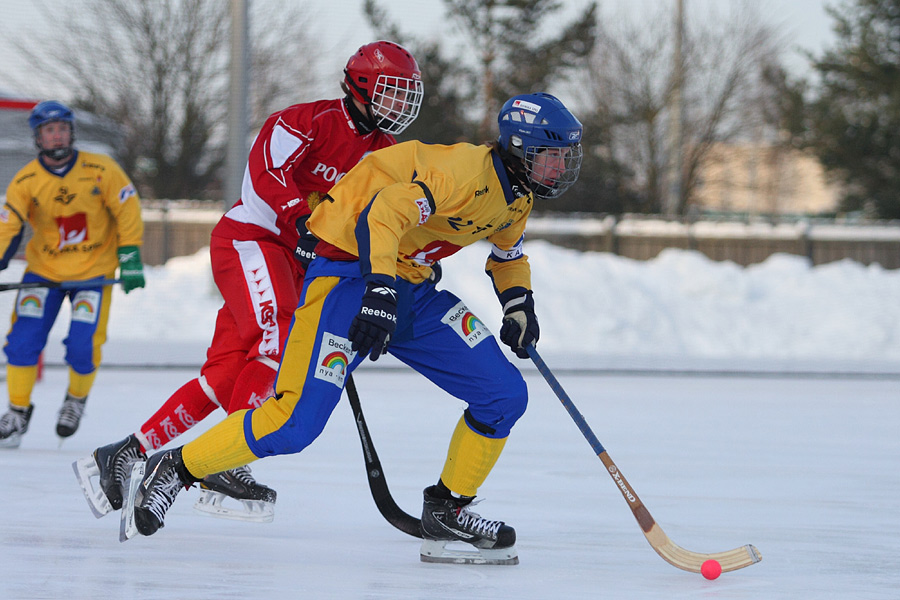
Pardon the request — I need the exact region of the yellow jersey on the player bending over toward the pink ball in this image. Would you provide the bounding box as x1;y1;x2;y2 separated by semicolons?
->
307;141;533;293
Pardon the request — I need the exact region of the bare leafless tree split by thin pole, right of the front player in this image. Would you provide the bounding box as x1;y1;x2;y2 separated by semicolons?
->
584;1;782;213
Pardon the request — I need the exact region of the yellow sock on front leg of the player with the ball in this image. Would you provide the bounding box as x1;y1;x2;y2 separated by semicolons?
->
441;417;507;496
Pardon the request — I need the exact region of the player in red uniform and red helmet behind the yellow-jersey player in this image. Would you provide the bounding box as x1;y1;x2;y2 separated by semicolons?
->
73;41;422;521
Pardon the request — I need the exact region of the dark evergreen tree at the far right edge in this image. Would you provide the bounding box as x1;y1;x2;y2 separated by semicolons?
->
793;0;900;219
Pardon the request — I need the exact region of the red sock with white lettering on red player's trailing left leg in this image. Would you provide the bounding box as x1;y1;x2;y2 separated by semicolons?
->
137;379;217;451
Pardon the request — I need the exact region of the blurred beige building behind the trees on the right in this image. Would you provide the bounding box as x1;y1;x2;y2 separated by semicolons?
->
694;144;841;215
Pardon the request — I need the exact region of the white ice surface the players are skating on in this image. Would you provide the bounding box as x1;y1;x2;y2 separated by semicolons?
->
0;365;900;600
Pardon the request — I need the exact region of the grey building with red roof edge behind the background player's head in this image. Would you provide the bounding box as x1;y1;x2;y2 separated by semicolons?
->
0;92;122;191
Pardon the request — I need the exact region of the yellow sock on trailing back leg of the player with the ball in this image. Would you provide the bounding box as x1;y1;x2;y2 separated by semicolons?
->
181;410;257;479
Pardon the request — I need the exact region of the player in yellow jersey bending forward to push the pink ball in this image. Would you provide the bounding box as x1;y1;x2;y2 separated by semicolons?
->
119;93;582;564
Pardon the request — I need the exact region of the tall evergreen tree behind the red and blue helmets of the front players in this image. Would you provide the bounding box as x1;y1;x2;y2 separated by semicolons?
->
364;0;631;212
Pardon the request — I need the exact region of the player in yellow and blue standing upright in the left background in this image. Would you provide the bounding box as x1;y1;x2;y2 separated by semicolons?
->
0;100;144;448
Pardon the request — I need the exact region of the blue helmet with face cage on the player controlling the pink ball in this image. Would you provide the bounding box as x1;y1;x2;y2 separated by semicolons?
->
497;92;583;198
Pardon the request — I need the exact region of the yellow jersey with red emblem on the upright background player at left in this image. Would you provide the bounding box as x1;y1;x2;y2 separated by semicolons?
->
0;151;144;281
